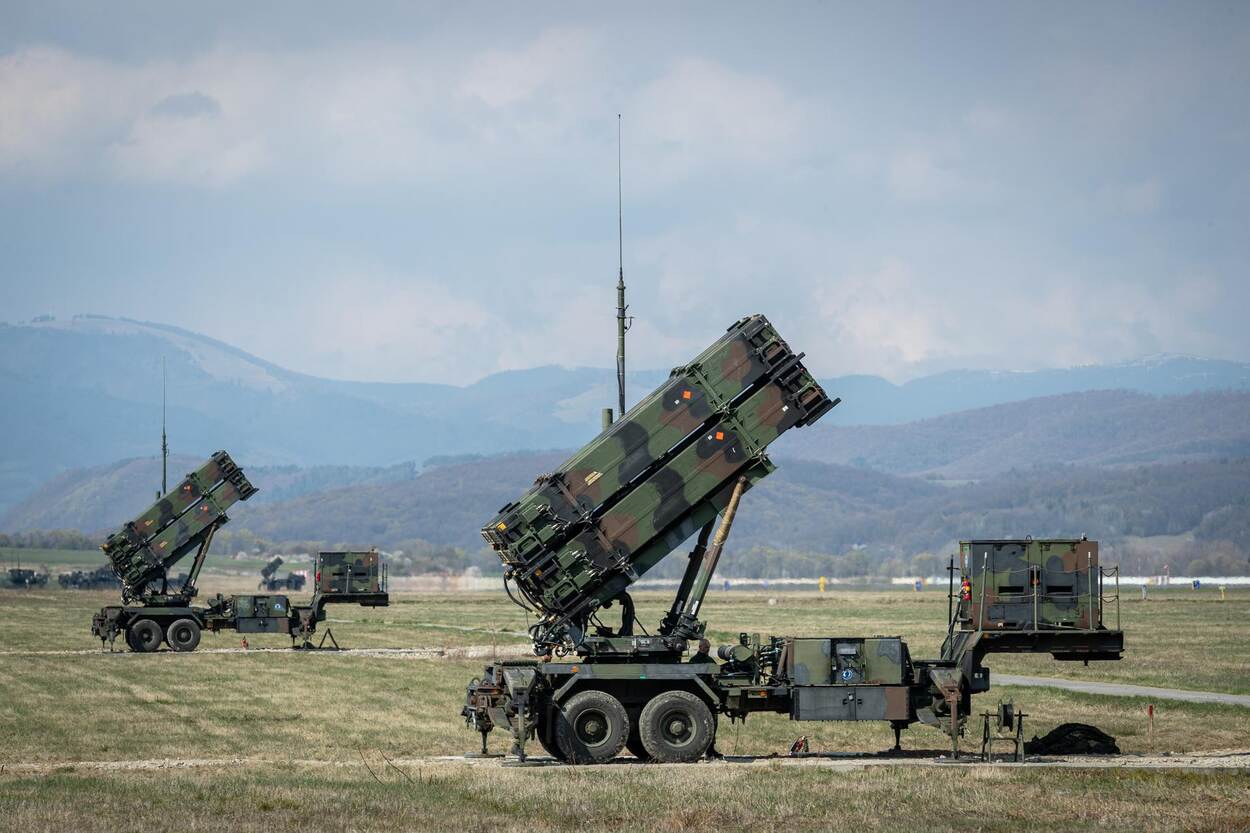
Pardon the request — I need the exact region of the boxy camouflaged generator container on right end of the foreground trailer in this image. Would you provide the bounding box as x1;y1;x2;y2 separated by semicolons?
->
959;538;1103;630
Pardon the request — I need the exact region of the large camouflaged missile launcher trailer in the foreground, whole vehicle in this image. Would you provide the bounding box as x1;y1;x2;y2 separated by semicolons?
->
461;311;1124;763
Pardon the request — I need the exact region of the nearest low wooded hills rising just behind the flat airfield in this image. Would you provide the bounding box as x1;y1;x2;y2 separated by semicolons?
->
4;453;1250;575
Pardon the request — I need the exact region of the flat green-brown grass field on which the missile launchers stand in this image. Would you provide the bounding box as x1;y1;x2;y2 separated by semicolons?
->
0;582;1250;830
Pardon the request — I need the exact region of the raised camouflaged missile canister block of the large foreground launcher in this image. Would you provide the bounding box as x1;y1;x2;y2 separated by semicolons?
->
483;315;838;654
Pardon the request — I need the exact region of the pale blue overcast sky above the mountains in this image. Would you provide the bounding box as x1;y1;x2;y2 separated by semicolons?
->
0;0;1250;381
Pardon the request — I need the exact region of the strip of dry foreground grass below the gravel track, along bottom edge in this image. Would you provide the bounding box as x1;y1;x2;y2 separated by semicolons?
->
0;758;1250;833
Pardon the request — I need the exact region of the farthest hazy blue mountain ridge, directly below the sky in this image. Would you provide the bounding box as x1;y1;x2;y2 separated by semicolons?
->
0;316;1250;513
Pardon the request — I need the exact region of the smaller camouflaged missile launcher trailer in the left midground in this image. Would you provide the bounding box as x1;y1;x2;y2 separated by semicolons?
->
91;452;389;652
